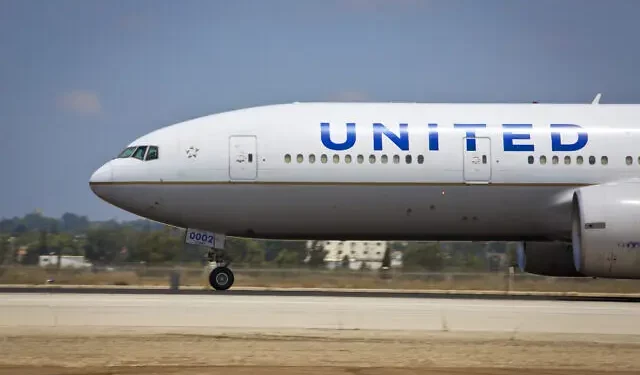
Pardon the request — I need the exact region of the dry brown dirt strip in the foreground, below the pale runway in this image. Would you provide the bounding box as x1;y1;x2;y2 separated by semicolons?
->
0;327;640;375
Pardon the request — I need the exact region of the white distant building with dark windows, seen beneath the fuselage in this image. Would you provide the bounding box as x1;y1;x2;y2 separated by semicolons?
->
307;241;402;270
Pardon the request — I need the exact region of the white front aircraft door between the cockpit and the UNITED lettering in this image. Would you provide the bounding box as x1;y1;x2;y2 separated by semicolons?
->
229;135;258;180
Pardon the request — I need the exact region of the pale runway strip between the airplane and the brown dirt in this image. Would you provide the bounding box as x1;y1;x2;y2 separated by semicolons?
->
0;293;640;336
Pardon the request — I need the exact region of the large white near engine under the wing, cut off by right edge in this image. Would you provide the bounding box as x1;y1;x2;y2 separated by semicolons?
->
572;181;640;279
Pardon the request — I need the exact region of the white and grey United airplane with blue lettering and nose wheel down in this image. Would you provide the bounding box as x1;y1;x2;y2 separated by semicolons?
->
89;94;640;290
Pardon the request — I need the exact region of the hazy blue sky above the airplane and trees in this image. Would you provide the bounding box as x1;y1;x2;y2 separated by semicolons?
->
0;0;640;220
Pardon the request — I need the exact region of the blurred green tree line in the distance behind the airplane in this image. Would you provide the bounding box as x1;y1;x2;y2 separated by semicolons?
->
0;213;514;271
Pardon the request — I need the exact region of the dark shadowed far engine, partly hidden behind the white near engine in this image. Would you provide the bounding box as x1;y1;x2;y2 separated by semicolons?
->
517;242;583;277
